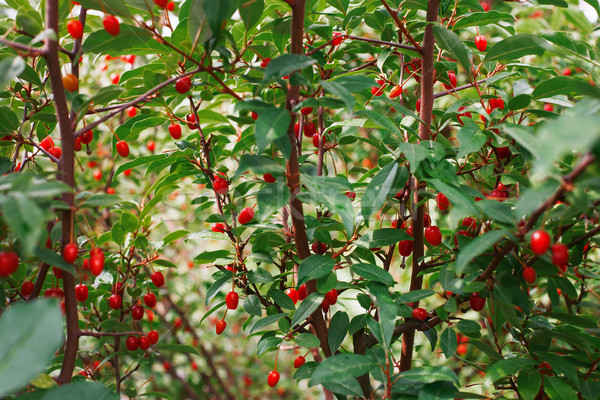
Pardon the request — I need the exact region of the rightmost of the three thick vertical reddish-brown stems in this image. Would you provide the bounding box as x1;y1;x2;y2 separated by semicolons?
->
400;0;440;371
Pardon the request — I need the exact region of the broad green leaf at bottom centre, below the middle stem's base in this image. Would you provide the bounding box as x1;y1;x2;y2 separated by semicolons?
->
309;354;377;386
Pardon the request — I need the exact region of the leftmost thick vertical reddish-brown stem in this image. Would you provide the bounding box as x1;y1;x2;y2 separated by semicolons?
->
45;0;79;383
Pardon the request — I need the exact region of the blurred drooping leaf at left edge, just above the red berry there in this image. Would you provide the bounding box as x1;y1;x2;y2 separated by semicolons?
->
2;192;45;256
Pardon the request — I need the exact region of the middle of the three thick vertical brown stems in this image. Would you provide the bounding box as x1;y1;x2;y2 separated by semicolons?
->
285;0;331;357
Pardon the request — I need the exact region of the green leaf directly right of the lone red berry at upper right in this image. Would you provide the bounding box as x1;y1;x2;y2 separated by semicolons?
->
483;33;549;62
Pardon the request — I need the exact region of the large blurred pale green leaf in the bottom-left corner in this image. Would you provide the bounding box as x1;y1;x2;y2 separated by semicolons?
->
0;299;63;396
